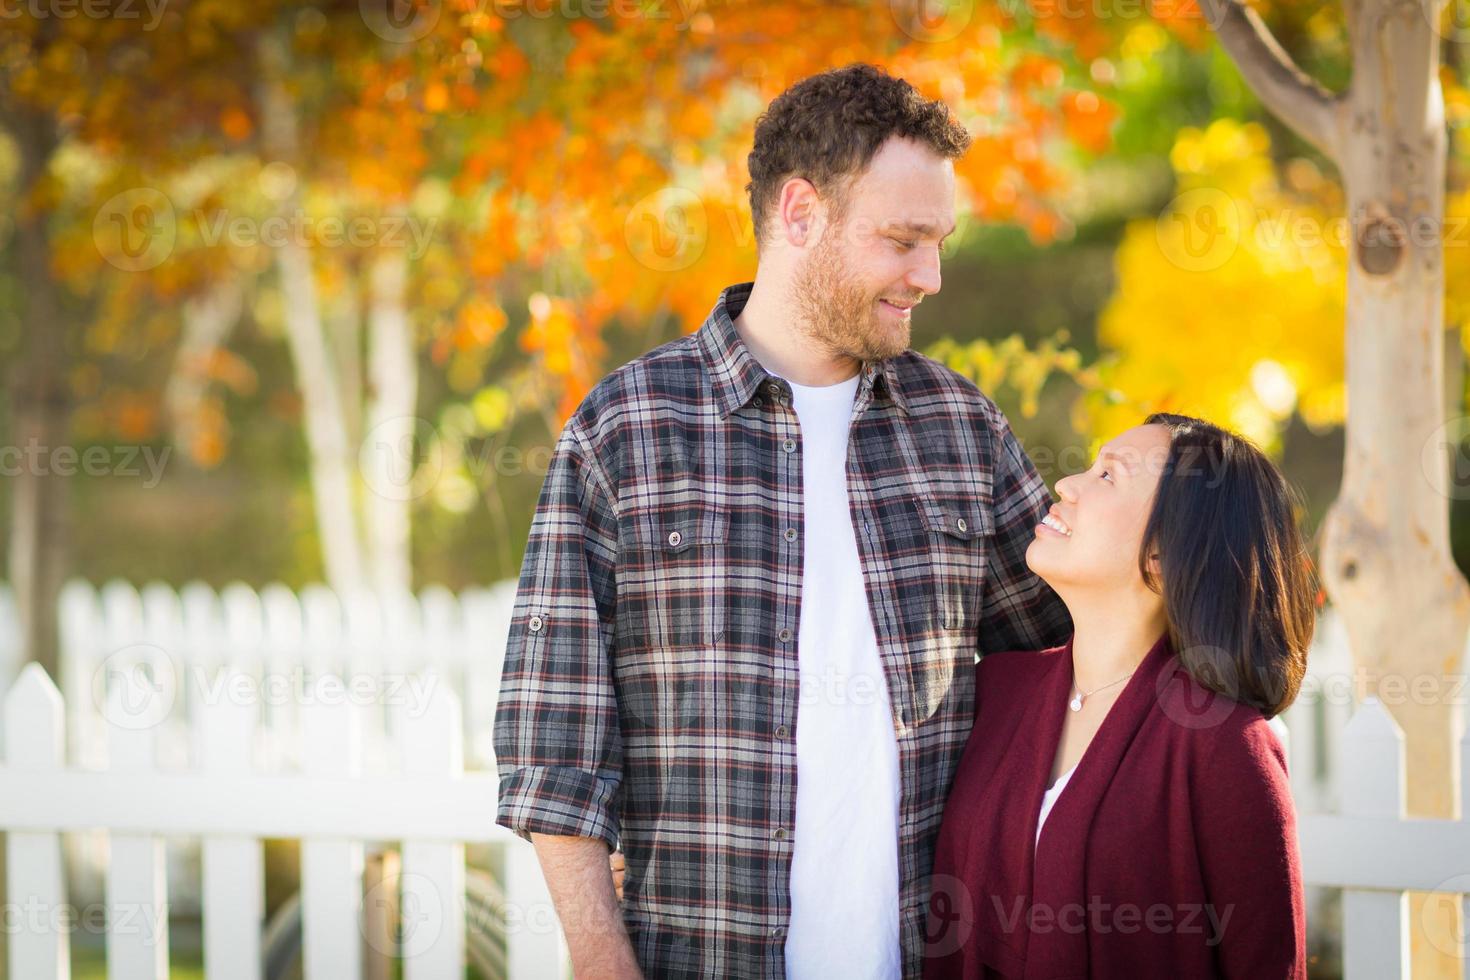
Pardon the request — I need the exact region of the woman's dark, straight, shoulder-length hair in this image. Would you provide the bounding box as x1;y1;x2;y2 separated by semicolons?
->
1138;413;1317;718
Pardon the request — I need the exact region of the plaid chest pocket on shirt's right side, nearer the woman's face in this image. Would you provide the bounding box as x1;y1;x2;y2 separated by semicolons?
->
916;494;995;629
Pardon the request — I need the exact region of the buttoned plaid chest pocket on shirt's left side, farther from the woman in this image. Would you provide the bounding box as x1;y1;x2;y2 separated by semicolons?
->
617;501;731;652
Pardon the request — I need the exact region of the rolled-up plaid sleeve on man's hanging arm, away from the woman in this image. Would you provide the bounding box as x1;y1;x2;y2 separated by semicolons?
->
494;417;622;846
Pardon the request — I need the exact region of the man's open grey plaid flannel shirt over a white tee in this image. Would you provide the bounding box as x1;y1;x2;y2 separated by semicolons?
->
494;284;1070;980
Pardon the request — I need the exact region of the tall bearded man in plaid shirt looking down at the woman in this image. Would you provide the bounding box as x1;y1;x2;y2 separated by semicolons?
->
495;65;1070;980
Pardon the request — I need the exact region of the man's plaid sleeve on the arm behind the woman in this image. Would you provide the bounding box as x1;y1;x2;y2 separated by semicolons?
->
979;408;1072;654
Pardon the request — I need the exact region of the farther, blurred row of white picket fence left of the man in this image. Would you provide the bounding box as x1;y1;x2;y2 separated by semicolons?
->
22;582;515;914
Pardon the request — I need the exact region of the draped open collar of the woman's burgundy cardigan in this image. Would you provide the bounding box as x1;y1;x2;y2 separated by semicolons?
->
1025;633;1173;979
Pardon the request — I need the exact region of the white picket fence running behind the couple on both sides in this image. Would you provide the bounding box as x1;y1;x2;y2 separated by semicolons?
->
0;582;1470;980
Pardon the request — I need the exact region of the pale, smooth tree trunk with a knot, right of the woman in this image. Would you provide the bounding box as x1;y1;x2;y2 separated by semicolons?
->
1202;0;1470;979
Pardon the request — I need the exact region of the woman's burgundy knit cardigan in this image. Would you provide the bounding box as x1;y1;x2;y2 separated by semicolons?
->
923;638;1307;980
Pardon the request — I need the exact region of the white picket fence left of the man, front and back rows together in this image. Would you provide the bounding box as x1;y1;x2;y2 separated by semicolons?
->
0;583;567;980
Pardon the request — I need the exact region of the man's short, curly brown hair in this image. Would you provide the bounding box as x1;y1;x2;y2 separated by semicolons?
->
745;63;970;247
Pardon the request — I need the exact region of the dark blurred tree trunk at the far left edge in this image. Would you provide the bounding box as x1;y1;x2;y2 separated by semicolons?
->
6;99;71;680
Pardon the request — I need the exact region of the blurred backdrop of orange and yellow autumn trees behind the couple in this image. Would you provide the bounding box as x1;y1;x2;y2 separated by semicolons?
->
0;0;1467;651
